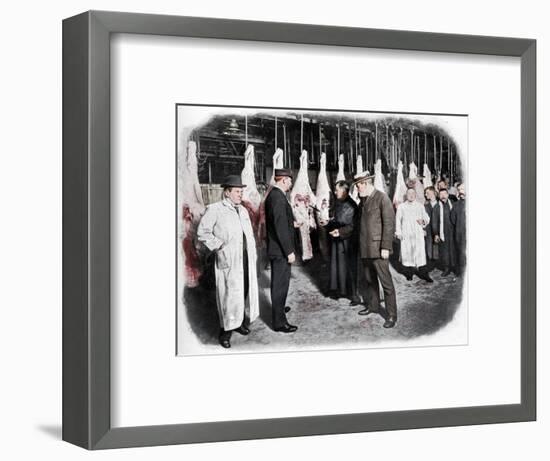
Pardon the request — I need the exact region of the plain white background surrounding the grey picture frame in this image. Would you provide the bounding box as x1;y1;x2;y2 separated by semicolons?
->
0;0;550;460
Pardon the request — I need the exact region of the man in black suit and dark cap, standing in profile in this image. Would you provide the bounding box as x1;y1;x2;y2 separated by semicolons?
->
265;168;298;333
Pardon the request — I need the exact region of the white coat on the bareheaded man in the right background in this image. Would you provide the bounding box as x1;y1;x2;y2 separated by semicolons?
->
395;201;430;267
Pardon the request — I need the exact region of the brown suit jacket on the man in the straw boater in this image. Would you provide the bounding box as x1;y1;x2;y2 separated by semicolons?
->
359;189;395;258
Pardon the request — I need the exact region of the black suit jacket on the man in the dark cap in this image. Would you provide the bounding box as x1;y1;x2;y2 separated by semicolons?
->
265;187;296;258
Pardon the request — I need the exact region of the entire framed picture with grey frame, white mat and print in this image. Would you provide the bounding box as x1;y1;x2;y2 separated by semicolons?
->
63;11;536;449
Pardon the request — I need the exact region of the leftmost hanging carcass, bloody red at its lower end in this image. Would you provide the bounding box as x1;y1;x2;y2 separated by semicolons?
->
179;141;205;287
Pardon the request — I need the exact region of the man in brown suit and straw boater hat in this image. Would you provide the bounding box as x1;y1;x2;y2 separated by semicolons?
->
354;171;397;328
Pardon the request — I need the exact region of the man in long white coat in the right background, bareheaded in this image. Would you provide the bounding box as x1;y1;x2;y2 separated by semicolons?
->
395;187;433;283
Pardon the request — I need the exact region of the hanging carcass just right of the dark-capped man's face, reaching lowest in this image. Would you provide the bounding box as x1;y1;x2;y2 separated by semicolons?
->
290;150;317;261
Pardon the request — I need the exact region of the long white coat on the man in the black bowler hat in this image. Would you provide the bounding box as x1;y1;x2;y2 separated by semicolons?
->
197;199;260;331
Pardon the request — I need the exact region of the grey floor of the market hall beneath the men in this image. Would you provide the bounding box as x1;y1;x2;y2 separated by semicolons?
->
184;246;465;355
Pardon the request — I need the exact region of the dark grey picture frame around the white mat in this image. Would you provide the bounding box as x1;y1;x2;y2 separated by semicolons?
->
63;11;536;449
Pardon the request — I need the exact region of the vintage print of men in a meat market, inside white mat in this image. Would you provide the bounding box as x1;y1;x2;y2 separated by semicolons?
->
175;104;468;356
